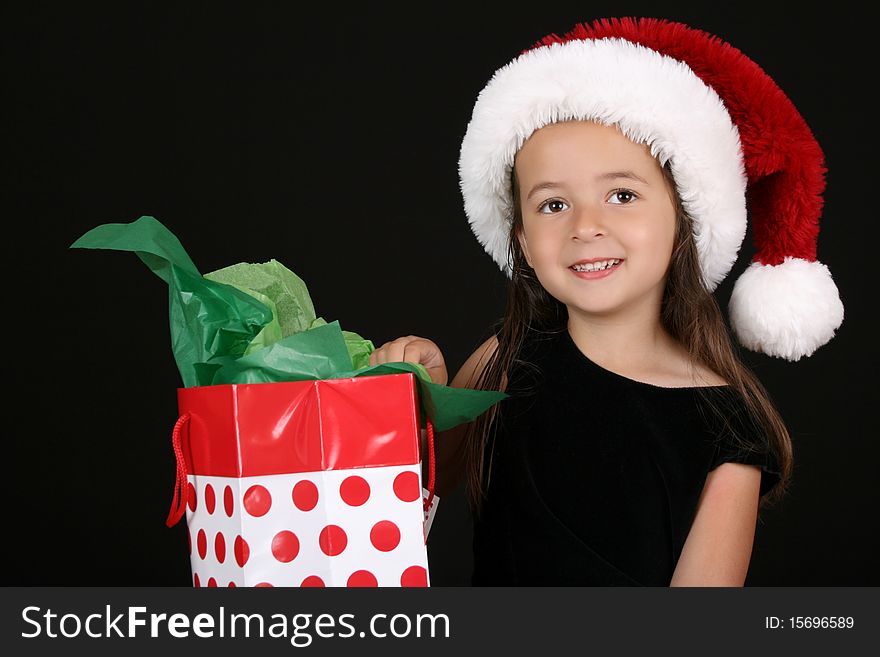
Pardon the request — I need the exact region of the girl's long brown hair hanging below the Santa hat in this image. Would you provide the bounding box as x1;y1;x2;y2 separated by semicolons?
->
462;147;793;516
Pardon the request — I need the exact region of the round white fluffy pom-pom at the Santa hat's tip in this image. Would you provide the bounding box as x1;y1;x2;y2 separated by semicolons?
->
728;257;843;361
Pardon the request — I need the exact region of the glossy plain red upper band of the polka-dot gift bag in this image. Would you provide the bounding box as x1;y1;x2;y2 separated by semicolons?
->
177;373;419;477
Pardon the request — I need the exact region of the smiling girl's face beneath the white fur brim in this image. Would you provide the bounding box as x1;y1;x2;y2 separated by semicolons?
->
514;121;676;317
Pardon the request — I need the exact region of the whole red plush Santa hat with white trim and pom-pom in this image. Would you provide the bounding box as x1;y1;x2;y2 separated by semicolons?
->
459;18;843;361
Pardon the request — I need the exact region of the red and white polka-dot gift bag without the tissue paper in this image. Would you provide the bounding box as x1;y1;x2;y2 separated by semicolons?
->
168;373;436;586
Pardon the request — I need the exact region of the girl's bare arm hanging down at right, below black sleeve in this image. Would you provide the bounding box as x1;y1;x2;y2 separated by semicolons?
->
670;463;761;586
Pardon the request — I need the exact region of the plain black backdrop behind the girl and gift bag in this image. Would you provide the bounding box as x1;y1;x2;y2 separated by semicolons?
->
0;2;880;586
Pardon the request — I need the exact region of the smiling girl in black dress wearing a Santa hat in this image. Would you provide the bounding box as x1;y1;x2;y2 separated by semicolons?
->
371;19;843;586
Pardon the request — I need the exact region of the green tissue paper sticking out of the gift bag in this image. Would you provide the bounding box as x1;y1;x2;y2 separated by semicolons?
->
71;216;508;431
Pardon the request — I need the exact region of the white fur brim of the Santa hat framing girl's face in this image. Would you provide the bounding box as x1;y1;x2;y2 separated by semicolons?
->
459;38;747;291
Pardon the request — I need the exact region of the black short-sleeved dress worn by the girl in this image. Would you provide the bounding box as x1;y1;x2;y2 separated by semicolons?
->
471;329;779;586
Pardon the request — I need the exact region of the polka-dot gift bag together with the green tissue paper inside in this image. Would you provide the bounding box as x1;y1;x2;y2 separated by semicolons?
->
71;216;507;586
